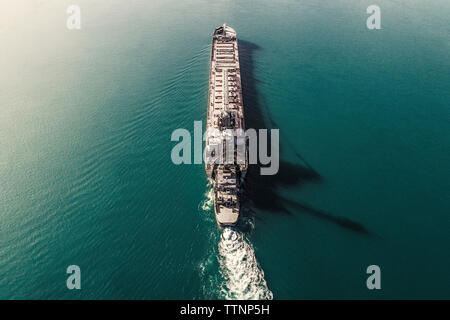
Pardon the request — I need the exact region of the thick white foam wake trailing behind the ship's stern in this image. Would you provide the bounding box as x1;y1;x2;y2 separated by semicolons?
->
219;228;273;300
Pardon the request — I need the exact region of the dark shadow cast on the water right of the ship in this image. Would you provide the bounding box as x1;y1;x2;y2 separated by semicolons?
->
239;40;371;235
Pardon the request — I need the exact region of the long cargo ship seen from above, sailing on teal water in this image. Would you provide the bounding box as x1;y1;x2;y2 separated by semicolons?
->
205;24;248;227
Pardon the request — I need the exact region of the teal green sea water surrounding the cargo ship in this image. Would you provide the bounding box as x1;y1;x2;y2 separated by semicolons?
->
0;0;450;299
